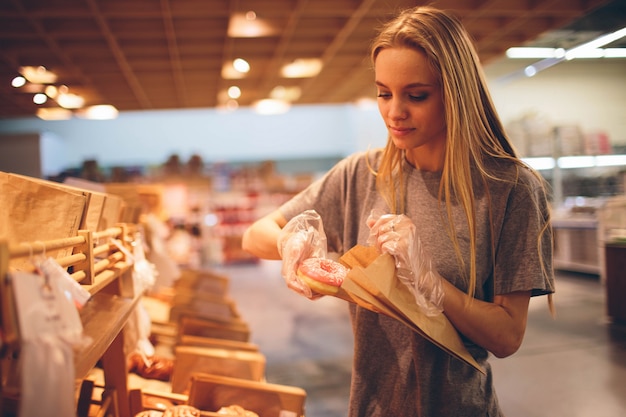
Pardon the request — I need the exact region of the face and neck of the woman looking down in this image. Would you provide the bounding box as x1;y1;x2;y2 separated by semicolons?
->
375;47;446;171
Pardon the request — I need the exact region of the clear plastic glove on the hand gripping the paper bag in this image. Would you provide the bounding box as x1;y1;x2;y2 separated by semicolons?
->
367;212;444;316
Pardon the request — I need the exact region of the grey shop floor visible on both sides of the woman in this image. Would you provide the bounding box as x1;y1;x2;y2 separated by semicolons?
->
217;261;626;417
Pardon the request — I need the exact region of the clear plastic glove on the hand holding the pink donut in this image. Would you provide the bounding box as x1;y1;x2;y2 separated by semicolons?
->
277;210;327;299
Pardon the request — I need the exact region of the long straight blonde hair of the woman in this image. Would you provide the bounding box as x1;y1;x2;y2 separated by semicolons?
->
371;6;549;296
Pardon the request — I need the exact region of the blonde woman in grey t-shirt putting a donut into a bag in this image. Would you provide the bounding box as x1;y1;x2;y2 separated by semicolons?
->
243;7;554;417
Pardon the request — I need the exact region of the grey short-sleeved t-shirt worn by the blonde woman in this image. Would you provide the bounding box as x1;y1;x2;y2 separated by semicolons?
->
280;151;553;417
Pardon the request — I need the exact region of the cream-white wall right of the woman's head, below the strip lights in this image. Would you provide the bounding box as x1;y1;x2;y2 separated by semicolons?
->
485;59;626;145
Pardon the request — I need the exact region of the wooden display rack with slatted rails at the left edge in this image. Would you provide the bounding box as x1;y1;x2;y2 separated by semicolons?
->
0;225;141;417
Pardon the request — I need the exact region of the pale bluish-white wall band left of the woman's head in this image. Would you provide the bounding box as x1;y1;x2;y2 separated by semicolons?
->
0;105;382;172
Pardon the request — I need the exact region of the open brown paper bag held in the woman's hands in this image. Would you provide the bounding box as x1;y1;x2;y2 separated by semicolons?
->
338;245;484;372
